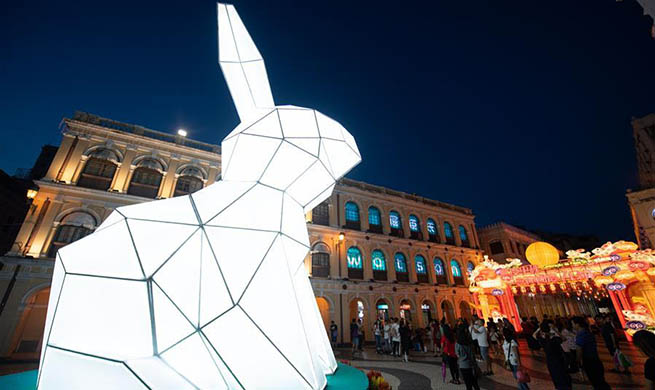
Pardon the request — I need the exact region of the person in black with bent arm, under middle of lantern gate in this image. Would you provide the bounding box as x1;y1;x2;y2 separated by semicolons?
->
532;321;571;390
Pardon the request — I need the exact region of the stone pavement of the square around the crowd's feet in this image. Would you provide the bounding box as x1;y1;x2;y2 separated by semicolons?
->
335;339;646;390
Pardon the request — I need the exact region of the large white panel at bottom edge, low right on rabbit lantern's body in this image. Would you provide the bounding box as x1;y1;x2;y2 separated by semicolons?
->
203;306;312;389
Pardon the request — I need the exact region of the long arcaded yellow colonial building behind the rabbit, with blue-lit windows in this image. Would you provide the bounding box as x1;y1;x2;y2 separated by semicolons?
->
0;113;482;359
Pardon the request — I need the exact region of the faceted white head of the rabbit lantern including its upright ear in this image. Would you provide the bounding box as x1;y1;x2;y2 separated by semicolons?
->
218;4;361;212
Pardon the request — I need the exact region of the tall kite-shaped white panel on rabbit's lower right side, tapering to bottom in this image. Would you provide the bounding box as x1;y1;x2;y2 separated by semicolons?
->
239;241;316;387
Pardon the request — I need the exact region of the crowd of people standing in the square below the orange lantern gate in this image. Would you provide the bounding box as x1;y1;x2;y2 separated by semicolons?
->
338;315;655;390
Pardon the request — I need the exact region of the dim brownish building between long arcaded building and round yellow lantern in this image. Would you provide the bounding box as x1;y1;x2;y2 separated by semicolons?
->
478;222;539;264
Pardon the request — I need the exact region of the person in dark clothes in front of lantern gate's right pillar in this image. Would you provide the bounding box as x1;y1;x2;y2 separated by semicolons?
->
573;317;610;390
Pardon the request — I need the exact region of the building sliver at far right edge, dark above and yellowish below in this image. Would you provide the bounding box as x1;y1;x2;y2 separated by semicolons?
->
626;114;655;248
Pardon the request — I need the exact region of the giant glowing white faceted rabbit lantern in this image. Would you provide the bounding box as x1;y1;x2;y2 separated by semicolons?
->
38;4;361;390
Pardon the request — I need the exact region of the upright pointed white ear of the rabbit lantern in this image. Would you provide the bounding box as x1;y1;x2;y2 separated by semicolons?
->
217;3;275;122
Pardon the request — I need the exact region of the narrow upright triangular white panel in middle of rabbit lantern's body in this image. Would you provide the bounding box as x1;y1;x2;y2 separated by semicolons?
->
199;233;233;326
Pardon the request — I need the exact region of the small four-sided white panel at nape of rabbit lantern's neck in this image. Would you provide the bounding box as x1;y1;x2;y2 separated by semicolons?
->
191;180;255;223
